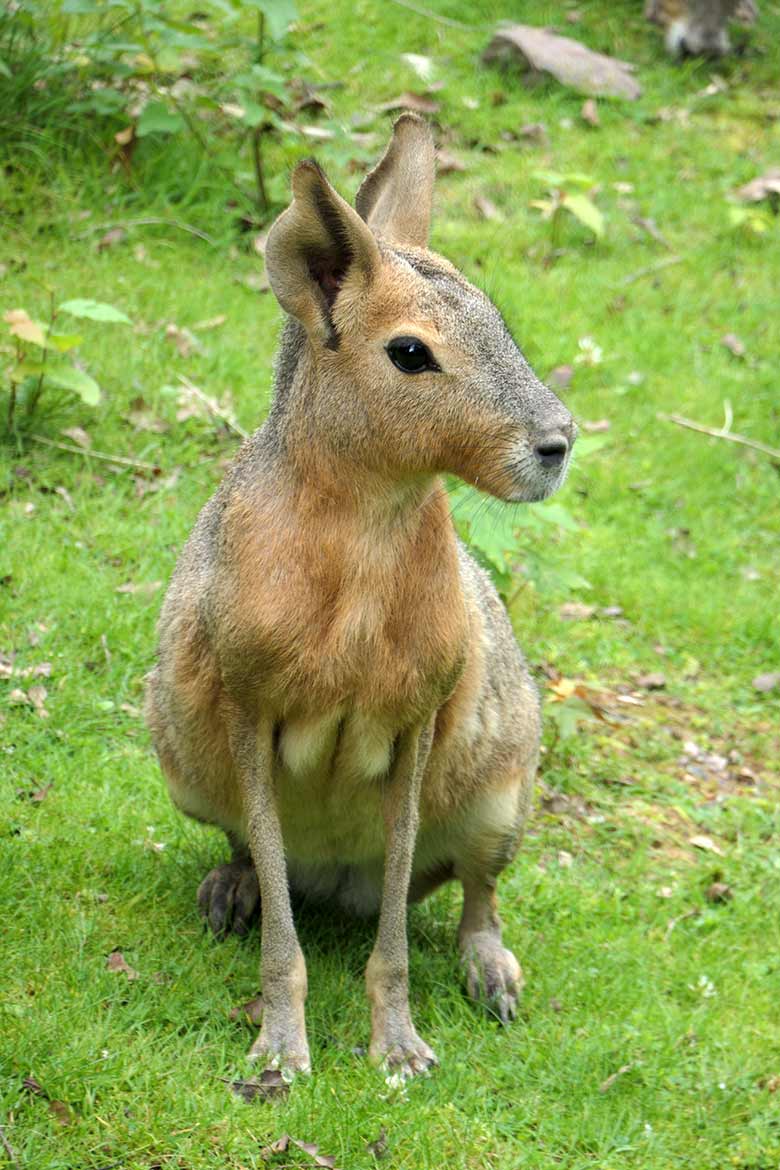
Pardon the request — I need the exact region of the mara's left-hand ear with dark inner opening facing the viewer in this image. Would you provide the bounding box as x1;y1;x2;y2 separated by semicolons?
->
265;160;380;349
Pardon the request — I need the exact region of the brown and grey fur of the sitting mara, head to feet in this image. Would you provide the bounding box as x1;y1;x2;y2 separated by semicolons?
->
147;116;574;1075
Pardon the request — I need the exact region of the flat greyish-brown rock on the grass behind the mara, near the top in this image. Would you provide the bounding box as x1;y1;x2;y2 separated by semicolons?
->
482;23;642;101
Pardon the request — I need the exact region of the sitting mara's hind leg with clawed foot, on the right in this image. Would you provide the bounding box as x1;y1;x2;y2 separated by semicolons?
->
455;777;532;1024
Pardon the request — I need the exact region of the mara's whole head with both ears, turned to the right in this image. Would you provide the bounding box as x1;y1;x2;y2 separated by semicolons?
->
265;115;575;501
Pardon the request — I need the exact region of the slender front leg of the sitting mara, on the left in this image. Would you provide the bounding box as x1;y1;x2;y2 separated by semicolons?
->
230;716;311;1073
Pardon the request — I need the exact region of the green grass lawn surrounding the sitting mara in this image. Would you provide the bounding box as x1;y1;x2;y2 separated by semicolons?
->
0;0;780;1170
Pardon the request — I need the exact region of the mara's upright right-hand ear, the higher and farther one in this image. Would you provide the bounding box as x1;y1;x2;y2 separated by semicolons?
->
354;113;436;248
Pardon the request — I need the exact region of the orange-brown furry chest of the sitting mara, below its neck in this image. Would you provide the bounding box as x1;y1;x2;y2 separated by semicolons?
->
219;475;470;711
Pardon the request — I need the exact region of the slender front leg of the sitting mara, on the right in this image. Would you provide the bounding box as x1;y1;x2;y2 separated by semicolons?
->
366;727;436;1078
